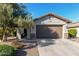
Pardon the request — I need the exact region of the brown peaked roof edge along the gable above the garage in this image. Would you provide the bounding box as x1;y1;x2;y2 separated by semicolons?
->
34;13;72;23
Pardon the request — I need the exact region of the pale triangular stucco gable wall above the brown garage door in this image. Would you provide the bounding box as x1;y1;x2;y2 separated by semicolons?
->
36;16;66;25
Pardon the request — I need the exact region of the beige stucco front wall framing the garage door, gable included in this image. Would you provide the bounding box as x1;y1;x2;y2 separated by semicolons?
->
31;17;66;38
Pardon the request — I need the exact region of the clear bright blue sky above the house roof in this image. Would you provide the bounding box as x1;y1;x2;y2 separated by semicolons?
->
25;3;79;22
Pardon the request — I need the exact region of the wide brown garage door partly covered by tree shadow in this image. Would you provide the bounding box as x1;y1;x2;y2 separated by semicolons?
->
36;25;62;39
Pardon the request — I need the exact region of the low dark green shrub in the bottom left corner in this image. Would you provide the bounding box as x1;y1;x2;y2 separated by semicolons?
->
0;45;16;56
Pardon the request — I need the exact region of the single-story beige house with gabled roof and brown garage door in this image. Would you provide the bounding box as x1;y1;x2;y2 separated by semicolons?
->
16;13;72;39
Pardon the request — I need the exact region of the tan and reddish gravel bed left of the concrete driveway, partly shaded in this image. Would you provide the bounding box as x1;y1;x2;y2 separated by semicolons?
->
16;41;39;56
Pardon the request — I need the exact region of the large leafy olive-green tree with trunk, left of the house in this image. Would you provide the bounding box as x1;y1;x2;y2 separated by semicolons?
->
0;3;33;41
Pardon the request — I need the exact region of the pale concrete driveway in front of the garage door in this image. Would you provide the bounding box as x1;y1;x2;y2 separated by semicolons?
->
38;39;79;56
